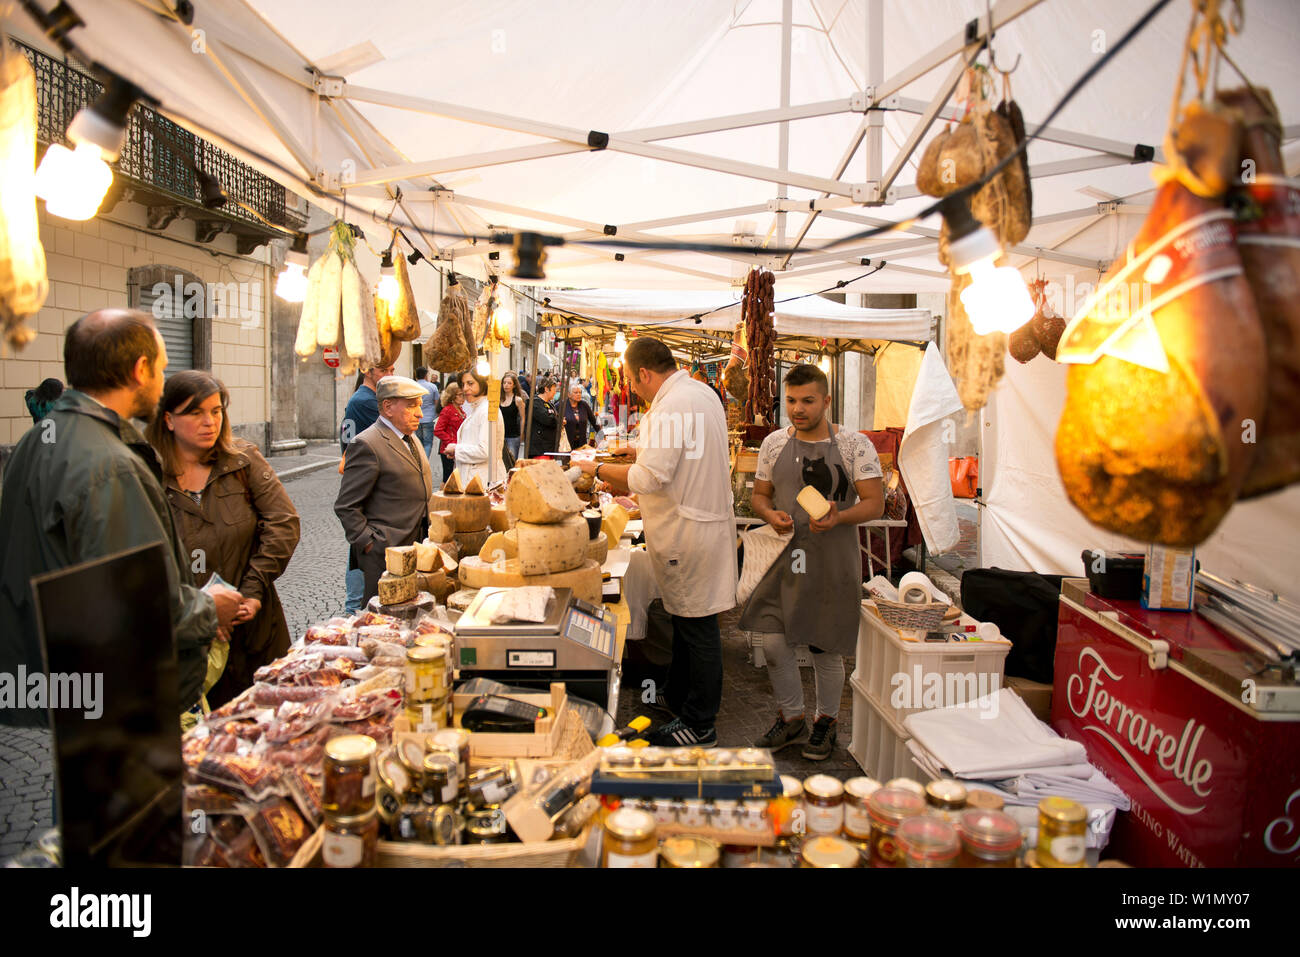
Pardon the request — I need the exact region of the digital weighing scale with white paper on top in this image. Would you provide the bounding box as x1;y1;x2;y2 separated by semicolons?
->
455;588;621;714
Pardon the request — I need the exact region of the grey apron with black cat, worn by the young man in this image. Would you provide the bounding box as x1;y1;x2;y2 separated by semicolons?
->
740;426;862;655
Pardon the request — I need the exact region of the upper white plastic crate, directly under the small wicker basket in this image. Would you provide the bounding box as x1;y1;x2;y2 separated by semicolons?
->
853;603;1011;727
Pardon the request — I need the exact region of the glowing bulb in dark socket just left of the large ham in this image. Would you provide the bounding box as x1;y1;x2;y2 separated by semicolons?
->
943;192;1034;335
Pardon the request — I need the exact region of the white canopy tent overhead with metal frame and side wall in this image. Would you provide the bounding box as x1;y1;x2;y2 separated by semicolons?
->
5;0;1300;596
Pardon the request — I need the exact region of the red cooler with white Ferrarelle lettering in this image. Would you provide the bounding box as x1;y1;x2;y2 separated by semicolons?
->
1052;579;1300;867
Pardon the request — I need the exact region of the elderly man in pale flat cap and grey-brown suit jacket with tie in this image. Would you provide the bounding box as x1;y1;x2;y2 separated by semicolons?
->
334;376;434;602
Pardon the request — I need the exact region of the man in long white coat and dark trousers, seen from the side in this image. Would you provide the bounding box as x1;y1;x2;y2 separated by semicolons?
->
579;337;736;748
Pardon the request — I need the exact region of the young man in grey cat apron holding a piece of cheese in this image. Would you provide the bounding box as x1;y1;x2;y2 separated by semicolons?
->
740;364;884;761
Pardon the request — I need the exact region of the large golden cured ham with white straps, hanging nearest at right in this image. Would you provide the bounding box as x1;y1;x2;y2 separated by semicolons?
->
1056;101;1268;547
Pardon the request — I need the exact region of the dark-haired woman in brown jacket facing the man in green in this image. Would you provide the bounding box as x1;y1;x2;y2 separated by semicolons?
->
150;371;299;707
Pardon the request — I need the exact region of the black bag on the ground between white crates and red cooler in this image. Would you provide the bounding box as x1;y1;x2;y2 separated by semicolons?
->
962;568;1065;684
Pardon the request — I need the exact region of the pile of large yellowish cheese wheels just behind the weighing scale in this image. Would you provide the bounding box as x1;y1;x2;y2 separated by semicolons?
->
459;462;603;605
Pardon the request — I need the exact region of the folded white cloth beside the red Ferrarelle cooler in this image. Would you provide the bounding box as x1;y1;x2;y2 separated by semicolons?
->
904;688;1088;780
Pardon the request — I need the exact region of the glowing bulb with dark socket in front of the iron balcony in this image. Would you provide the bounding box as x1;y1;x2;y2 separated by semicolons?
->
36;77;142;220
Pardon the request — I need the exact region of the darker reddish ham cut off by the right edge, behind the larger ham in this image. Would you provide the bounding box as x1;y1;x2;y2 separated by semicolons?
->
1217;87;1300;498
